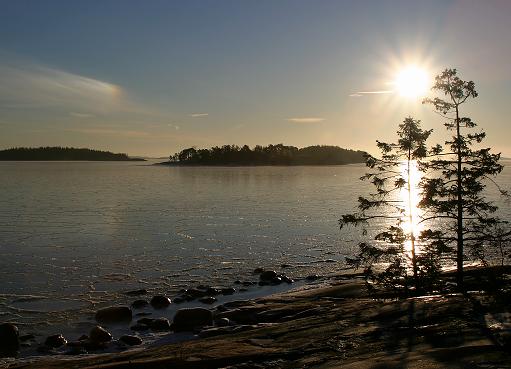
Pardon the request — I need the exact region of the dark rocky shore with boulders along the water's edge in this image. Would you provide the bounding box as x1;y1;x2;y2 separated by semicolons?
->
0;268;511;368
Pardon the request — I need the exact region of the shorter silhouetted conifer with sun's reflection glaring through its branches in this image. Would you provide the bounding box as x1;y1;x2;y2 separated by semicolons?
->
339;117;438;289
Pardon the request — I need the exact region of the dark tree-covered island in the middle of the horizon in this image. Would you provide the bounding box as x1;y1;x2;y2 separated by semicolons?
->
159;144;366;166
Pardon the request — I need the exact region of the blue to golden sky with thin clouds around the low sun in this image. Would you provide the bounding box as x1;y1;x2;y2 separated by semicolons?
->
0;0;511;157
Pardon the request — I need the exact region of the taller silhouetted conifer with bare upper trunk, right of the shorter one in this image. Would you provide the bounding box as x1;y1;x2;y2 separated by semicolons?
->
419;69;506;289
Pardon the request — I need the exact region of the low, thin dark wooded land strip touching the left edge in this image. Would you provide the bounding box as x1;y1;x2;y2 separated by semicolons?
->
0;147;145;161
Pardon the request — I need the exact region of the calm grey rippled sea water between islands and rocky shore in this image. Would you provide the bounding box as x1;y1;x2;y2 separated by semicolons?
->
0;161;511;344
